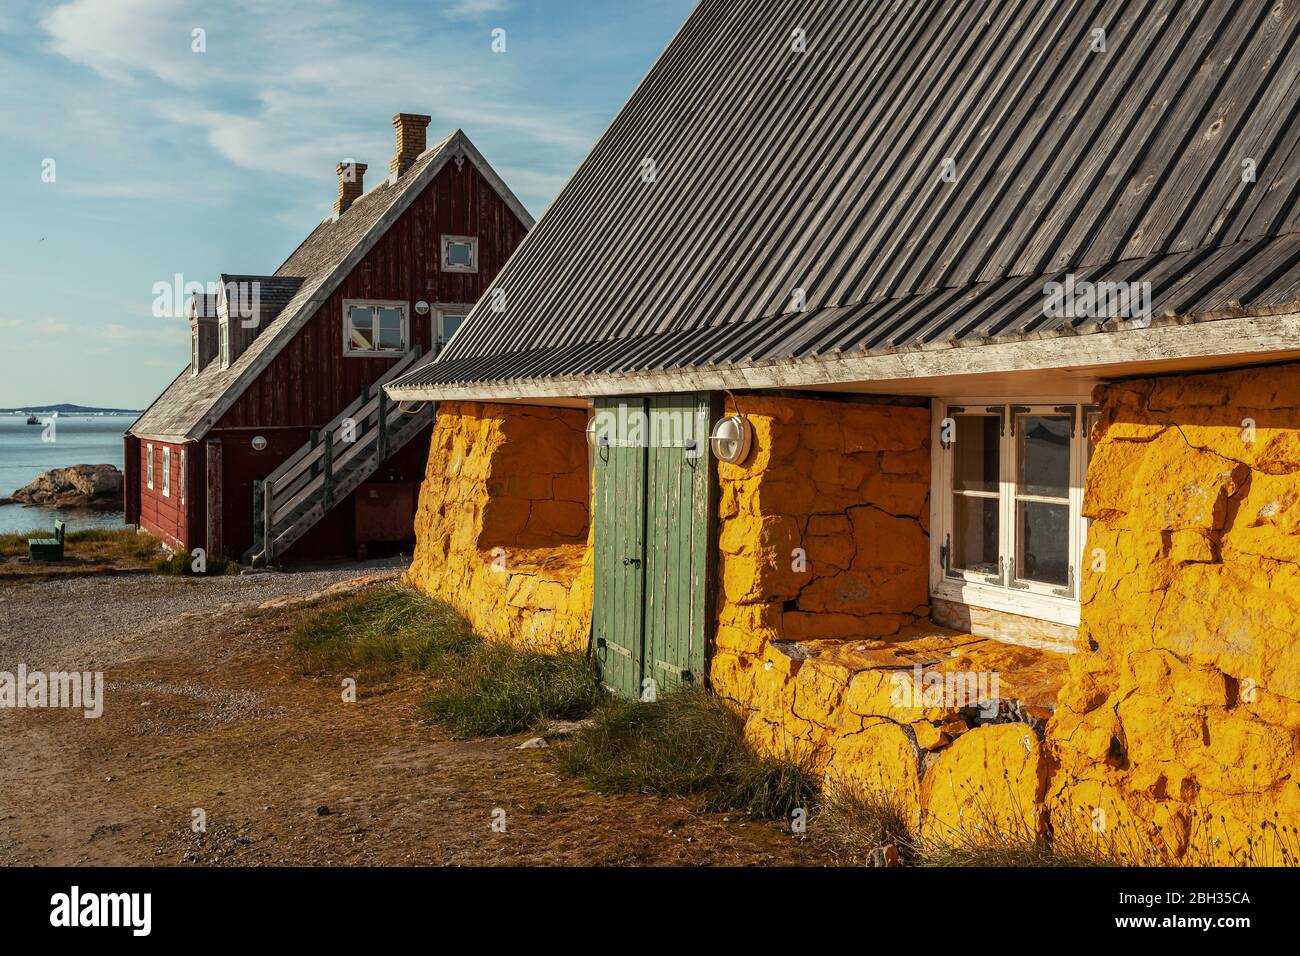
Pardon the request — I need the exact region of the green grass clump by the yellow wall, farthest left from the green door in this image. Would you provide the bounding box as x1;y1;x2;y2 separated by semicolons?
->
290;587;478;676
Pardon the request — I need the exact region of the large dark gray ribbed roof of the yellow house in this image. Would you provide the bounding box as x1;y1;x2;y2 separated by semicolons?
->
394;0;1300;390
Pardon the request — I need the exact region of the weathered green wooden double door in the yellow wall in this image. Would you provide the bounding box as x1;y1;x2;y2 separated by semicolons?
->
593;394;716;697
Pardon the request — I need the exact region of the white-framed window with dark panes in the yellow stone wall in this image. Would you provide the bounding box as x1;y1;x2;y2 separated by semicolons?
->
931;398;1097;626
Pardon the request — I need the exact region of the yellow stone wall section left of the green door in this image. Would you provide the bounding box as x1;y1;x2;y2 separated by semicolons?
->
407;402;592;650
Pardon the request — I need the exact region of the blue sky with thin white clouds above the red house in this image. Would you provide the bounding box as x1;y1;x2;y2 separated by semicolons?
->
0;0;693;408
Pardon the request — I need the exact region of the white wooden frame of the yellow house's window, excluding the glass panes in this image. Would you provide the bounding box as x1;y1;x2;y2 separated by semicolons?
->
930;395;1096;627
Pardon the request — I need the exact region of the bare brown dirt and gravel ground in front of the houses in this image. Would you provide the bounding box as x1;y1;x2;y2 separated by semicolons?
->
0;566;826;865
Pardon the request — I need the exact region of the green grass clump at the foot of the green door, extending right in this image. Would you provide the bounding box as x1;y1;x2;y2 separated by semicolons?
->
555;689;818;819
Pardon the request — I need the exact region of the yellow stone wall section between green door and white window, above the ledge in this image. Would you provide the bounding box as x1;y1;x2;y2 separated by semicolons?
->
716;395;930;672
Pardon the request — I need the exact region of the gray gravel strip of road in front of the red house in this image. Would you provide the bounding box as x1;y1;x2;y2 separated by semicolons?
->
0;559;403;671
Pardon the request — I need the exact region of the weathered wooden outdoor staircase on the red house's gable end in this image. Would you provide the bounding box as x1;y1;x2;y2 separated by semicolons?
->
244;346;433;567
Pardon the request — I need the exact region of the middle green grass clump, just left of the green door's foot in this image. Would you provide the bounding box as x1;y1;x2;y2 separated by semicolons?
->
423;641;605;737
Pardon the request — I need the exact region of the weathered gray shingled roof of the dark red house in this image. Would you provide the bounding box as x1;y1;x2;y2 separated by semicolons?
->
130;130;533;441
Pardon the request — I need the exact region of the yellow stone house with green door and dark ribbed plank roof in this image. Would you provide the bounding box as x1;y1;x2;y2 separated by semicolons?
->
389;0;1300;864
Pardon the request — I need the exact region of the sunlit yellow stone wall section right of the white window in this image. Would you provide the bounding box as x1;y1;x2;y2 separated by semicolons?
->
1048;365;1300;864
